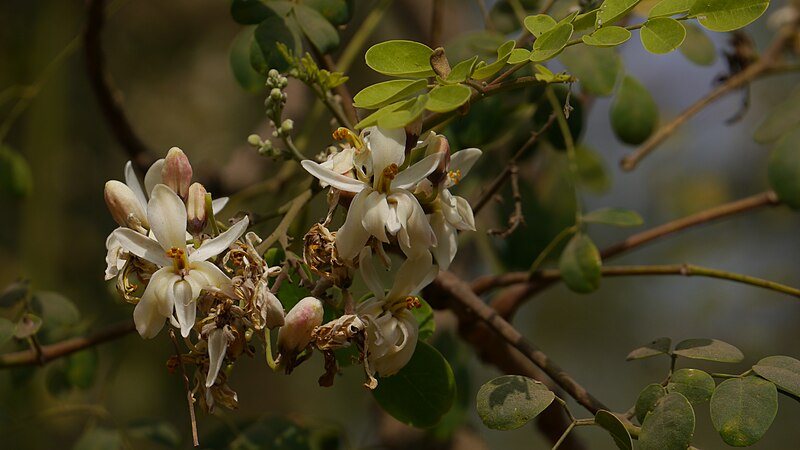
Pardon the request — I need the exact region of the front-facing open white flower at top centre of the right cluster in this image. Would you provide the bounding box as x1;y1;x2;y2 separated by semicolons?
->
302;128;441;260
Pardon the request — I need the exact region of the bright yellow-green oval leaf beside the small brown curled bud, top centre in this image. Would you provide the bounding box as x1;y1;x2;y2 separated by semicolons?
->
364;41;434;78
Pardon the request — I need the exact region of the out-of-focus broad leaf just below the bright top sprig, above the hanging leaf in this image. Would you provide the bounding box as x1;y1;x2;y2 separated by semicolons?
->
558;45;622;96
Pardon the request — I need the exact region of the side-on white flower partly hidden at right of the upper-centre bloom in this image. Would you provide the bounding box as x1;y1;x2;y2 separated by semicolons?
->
430;148;481;270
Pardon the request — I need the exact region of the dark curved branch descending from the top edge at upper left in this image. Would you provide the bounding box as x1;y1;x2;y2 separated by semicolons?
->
83;0;155;173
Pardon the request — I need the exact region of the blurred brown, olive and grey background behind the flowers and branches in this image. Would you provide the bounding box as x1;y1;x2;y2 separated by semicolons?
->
0;0;800;449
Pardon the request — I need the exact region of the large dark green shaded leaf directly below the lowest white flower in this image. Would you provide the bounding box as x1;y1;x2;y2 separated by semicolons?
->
372;342;455;428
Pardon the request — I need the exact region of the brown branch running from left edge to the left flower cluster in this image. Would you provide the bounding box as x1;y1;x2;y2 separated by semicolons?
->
0;321;136;369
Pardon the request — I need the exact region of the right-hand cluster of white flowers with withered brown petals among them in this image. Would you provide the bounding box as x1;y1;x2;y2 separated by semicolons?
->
302;127;481;388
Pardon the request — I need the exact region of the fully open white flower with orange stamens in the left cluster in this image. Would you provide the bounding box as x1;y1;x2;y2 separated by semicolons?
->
114;184;248;338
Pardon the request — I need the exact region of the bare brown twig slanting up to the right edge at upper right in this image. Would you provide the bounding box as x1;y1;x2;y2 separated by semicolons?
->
620;21;797;170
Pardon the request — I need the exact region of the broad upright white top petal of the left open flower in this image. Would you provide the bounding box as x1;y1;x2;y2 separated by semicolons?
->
147;185;186;250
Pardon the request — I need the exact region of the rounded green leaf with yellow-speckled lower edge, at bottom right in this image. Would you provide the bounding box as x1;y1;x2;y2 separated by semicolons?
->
711;377;778;447
